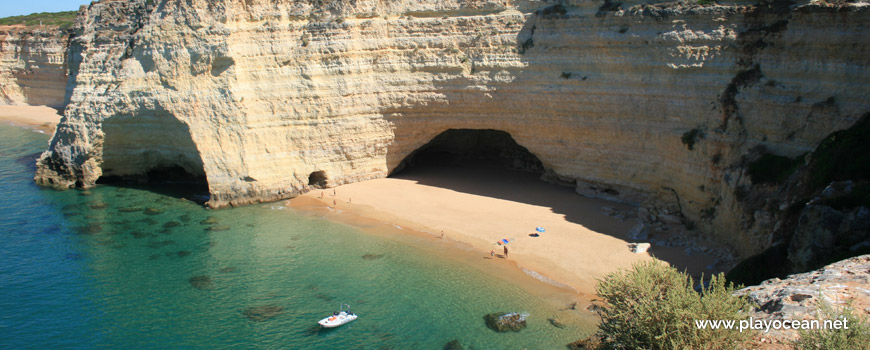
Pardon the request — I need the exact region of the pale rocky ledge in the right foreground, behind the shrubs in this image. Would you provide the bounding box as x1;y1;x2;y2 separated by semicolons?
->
735;255;870;339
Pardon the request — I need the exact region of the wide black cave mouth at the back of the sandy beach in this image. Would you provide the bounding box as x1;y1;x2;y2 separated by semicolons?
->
390;129;544;176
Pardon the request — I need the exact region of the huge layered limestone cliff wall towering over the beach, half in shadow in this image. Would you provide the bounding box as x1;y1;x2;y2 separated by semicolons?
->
29;0;870;254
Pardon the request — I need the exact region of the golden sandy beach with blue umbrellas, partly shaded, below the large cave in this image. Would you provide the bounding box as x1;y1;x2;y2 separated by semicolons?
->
291;161;713;295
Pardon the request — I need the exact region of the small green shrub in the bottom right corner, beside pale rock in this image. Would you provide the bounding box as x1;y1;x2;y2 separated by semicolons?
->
794;299;870;350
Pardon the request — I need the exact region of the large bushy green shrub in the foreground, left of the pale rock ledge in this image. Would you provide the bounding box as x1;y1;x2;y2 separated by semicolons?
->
596;261;752;350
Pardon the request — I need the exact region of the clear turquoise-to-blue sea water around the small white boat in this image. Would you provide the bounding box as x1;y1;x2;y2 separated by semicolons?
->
0;125;590;349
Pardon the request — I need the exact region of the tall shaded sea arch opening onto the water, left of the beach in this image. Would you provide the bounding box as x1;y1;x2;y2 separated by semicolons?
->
97;111;208;201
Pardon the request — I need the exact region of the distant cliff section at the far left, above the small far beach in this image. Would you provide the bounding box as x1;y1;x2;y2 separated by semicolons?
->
0;26;68;108
